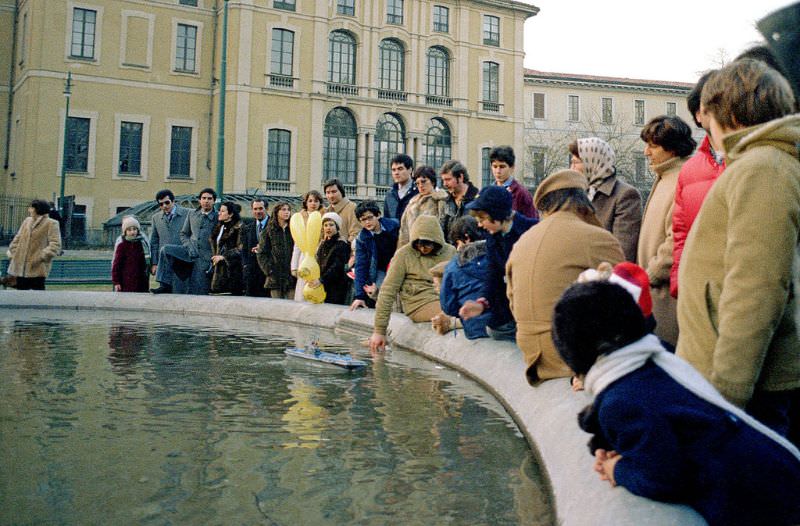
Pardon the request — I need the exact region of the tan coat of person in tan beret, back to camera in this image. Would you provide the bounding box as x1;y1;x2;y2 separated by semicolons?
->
506;211;625;383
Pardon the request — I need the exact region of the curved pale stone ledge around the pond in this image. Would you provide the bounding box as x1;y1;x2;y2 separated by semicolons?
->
0;291;705;526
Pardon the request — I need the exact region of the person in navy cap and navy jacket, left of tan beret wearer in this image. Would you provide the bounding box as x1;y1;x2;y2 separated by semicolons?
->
458;186;538;341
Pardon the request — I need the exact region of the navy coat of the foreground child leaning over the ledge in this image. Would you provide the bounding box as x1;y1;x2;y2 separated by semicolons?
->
584;361;800;526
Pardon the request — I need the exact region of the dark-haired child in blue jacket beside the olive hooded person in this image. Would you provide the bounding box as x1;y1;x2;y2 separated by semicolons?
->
439;216;491;340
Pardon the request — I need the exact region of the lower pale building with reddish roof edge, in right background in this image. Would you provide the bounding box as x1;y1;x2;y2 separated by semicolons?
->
524;69;705;196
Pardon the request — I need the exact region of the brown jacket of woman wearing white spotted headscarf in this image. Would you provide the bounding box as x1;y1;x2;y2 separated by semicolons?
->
592;176;642;262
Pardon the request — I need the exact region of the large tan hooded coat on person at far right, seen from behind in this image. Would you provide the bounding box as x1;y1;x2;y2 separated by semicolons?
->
677;115;800;407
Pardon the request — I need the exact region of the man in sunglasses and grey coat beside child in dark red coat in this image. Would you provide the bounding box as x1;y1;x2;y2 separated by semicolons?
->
150;189;189;292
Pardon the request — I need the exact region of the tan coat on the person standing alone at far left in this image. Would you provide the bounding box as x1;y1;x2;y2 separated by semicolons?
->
8;215;61;278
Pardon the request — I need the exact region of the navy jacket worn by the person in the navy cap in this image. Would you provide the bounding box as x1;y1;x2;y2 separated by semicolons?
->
481;213;539;328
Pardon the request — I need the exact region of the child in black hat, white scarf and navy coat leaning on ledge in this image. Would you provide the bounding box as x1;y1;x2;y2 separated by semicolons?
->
553;281;800;526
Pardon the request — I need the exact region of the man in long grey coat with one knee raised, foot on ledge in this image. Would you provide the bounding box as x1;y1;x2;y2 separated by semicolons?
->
152;188;217;294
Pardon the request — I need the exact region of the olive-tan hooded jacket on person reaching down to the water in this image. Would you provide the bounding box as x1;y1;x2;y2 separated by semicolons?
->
374;215;456;334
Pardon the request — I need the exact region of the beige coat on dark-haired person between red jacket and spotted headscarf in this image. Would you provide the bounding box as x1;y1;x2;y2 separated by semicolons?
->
636;157;687;345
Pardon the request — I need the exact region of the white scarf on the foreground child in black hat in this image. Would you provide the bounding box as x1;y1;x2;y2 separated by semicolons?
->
583;334;800;461
